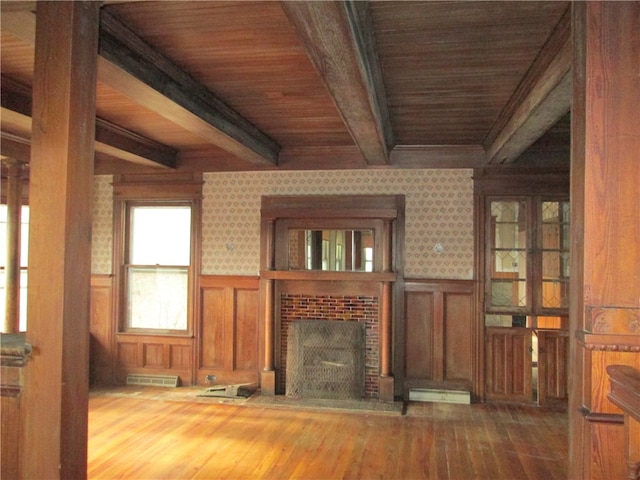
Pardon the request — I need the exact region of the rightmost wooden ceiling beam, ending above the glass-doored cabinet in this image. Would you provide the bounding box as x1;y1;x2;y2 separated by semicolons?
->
484;9;572;164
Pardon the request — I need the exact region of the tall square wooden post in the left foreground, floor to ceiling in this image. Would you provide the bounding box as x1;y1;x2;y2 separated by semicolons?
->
21;1;100;479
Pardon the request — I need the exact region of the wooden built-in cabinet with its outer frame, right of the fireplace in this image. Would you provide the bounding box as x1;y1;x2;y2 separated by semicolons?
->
474;168;570;405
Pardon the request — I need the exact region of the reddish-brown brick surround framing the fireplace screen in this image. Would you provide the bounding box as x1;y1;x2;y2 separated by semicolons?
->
277;294;379;399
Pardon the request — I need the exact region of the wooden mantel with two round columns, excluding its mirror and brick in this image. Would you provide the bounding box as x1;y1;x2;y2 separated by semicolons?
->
260;195;404;401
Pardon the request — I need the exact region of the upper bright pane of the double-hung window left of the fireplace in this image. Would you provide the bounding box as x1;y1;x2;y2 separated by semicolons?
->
129;206;191;265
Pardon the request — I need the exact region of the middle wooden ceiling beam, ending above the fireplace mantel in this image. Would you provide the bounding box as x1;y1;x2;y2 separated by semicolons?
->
282;1;393;165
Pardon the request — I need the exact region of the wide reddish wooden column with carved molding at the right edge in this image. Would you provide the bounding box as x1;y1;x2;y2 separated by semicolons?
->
568;2;640;479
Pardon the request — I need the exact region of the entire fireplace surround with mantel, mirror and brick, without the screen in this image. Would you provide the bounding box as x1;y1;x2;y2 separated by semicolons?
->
260;195;405;402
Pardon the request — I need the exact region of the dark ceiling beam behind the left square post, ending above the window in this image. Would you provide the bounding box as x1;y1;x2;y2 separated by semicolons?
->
0;76;178;168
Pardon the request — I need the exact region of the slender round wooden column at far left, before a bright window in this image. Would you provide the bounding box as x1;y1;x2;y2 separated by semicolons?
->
2;159;22;333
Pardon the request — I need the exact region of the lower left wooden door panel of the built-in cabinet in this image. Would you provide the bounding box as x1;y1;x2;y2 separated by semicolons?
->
485;327;533;402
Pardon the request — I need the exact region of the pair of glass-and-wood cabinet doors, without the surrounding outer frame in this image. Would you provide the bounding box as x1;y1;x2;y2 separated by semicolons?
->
484;196;569;404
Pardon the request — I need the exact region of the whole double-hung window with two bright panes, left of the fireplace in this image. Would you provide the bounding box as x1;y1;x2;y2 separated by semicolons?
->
123;202;194;333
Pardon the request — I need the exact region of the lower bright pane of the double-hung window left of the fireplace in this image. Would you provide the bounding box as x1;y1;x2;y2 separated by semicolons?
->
127;267;188;330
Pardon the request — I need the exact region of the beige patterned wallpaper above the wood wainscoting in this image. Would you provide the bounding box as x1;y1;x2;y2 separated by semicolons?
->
93;169;473;279
